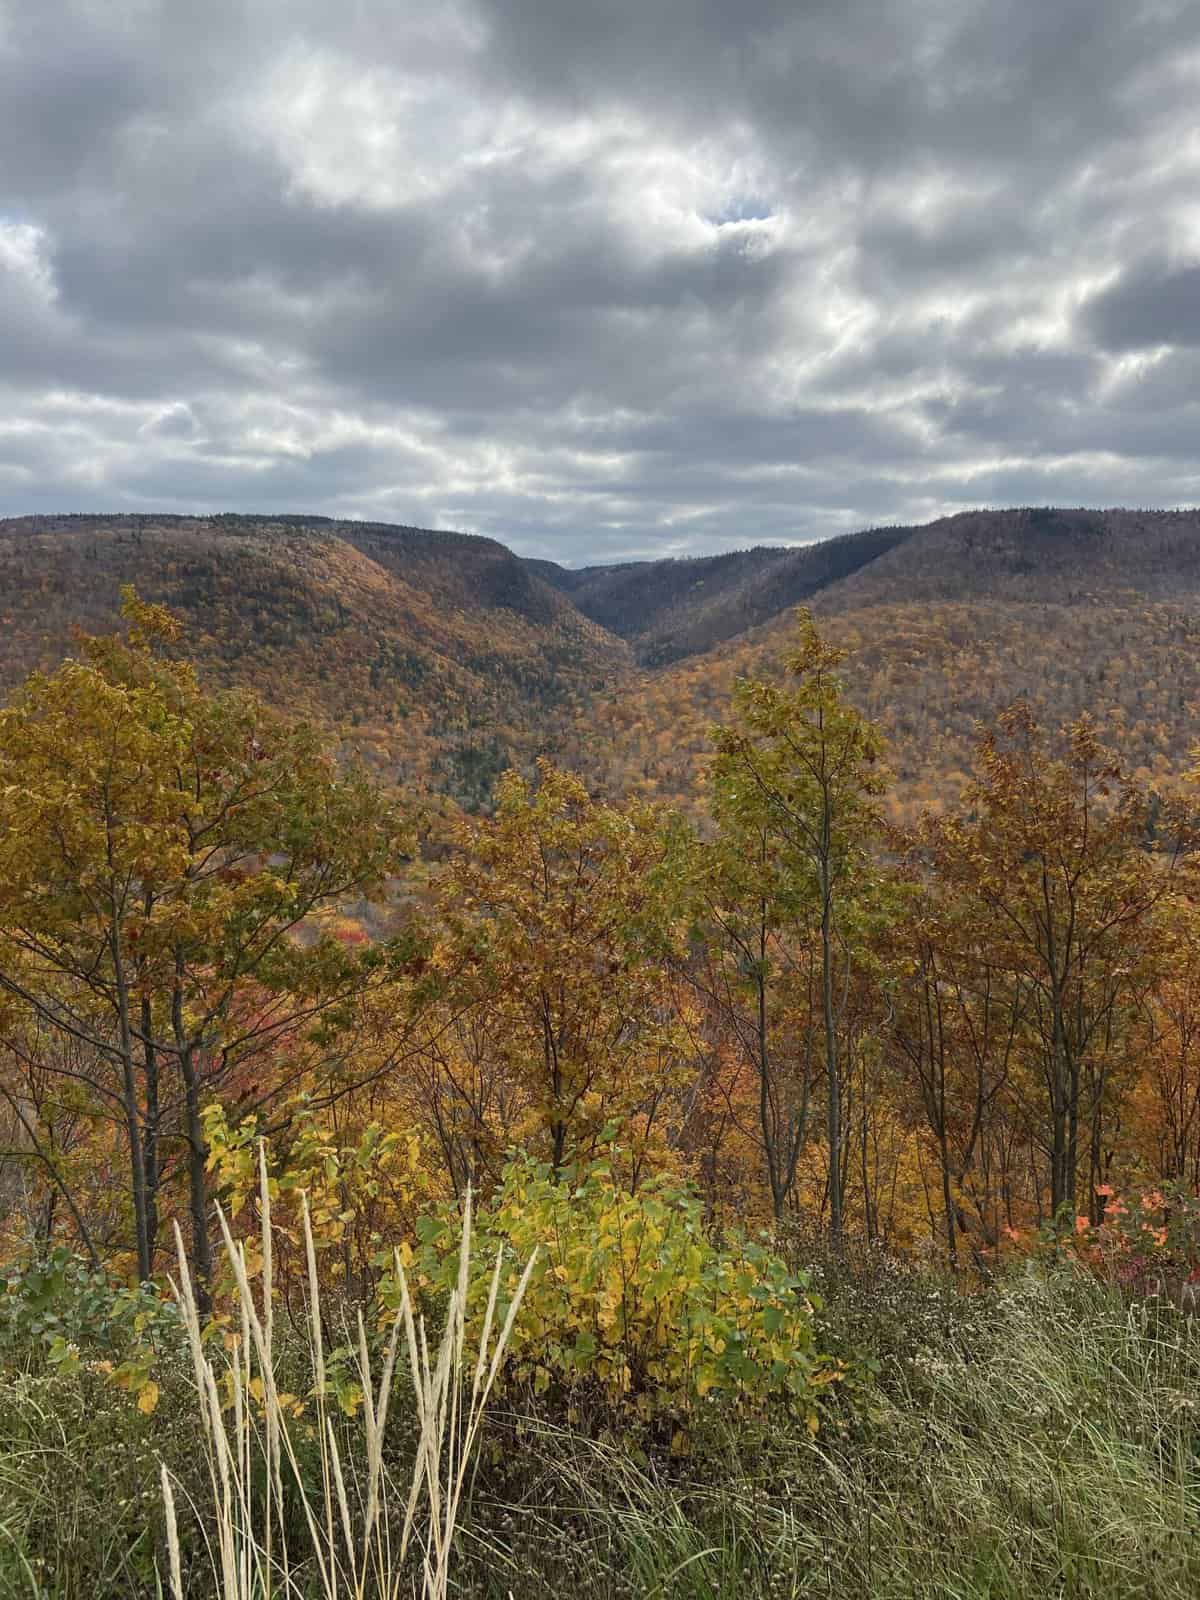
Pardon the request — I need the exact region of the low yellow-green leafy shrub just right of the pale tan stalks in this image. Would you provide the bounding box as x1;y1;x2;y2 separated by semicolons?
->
396;1158;842;1430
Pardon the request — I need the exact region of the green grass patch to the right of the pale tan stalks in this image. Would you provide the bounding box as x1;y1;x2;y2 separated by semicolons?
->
454;1277;1200;1600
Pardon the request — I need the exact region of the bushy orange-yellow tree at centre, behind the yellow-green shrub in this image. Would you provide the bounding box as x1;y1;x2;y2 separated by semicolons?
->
438;762;691;1182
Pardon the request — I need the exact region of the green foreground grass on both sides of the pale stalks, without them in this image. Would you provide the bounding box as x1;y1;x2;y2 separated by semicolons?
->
0;1262;1200;1600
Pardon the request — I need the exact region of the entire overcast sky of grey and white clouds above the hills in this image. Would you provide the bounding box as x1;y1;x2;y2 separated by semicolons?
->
0;0;1200;562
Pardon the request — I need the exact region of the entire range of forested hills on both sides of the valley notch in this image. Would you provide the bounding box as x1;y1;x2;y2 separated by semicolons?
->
0;507;1200;814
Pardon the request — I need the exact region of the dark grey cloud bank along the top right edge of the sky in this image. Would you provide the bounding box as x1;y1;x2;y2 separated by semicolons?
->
480;0;1195;174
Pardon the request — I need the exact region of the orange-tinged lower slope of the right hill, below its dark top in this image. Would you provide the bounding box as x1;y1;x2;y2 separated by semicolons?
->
566;602;1200;816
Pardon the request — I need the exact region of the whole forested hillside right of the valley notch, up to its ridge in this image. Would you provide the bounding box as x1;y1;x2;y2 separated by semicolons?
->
568;510;1200;818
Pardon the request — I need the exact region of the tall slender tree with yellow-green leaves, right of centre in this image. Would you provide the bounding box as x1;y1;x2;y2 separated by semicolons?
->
707;610;885;1242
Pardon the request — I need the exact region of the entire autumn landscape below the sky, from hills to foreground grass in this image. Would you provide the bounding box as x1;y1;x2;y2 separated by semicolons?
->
0;509;1200;1600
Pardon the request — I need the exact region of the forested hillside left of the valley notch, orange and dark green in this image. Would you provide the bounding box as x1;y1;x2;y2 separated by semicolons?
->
0;517;629;803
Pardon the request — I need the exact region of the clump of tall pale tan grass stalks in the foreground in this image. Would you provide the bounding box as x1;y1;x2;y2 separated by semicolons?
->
162;1150;533;1600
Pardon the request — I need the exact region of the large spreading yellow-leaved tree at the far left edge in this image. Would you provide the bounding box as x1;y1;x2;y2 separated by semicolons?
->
0;590;403;1283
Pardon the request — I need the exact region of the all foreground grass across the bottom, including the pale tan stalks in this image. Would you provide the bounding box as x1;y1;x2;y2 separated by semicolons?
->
0;1226;1200;1600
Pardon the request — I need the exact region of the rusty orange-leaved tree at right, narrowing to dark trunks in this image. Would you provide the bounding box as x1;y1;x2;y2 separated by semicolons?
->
922;701;1189;1216
